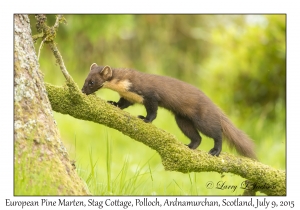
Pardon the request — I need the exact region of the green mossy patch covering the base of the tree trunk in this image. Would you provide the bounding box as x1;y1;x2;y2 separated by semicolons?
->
14;140;87;195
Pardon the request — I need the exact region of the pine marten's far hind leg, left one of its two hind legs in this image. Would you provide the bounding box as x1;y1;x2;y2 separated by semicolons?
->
175;115;201;149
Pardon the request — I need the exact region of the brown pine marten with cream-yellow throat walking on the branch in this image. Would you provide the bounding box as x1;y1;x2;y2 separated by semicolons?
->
82;63;256;159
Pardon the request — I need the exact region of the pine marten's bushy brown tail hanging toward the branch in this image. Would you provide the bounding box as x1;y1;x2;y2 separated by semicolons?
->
221;115;257;159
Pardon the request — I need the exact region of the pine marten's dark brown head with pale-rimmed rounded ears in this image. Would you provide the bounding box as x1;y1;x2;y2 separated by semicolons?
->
81;63;112;95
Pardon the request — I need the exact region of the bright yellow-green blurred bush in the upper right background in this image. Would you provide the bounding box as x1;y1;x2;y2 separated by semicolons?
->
206;15;286;118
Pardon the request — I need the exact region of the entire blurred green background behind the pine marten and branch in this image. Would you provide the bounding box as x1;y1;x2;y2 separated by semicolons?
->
30;15;286;195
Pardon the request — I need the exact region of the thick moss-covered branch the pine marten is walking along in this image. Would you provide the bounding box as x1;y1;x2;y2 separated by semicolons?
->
46;84;286;195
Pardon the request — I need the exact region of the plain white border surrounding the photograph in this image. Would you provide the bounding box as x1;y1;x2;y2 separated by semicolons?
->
0;0;300;209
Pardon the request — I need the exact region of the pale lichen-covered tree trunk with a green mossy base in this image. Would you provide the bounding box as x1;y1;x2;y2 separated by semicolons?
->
14;15;89;195
